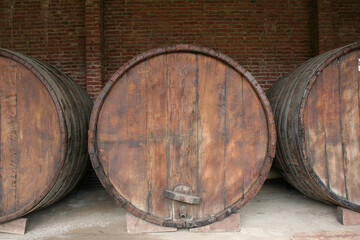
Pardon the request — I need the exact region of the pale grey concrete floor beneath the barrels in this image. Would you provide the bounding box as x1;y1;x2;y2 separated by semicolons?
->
0;179;360;240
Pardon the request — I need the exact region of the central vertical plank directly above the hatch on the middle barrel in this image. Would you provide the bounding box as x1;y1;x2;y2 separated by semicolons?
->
167;54;199;194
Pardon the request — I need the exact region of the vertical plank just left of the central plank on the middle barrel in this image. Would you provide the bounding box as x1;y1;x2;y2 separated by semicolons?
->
144;56;171;218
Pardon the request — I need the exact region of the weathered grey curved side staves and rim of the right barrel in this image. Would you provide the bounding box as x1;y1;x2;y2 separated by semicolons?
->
267;42;360;211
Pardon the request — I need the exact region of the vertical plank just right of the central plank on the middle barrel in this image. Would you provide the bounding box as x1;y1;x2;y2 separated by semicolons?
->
198;52;226;217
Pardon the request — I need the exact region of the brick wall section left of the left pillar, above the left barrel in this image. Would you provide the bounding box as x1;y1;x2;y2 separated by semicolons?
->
0;0;86;88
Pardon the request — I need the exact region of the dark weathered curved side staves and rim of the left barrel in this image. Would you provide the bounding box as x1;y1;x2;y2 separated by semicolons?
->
0;48;92;223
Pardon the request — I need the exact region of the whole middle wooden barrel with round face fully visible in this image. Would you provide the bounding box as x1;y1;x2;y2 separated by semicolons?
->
89;45;276;228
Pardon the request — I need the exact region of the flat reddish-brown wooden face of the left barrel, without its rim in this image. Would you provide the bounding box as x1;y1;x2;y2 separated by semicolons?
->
0;58;61;216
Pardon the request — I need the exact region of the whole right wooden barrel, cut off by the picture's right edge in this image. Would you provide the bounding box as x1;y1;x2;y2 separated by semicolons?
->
268;43;360;211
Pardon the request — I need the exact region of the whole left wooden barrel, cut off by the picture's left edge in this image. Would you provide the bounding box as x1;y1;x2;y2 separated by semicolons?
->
0;49;92;222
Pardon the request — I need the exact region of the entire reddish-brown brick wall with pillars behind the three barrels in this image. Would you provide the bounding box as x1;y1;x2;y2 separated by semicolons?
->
0;0;360;99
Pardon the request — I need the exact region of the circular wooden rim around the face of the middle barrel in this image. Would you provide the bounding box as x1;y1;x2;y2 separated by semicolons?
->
88;44;276;228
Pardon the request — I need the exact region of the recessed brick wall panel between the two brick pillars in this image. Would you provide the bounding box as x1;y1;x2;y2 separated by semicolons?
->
104;0;312;88
